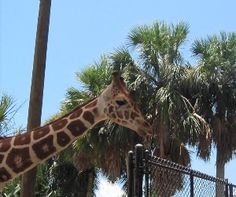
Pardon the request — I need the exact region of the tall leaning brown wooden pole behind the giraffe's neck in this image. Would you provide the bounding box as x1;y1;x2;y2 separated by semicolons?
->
21;0;51;197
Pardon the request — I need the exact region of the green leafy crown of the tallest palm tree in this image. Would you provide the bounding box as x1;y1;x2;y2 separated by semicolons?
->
128;21;188;69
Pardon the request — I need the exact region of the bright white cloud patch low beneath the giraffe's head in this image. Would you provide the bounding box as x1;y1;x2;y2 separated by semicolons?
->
96;179;125;197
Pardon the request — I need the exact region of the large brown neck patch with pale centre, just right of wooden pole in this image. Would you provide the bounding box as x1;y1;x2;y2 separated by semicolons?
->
32;135;56;159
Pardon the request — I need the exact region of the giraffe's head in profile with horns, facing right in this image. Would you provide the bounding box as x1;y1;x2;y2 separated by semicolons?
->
102;73;152;136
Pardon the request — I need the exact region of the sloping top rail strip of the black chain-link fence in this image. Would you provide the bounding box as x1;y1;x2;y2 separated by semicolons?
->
148;154;231;187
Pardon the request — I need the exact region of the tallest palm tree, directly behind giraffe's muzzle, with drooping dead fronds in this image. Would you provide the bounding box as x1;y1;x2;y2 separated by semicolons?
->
126;22;209;165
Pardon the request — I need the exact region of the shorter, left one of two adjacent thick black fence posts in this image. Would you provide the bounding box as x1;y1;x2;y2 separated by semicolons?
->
127;151;134;197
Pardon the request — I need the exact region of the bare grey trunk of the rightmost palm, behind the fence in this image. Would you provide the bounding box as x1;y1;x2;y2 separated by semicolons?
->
216;146;225;197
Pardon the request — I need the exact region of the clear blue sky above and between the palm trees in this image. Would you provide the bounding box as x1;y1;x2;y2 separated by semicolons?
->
0;0;236;194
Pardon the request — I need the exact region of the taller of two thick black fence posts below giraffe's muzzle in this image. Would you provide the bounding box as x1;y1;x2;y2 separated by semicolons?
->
134;144;143;197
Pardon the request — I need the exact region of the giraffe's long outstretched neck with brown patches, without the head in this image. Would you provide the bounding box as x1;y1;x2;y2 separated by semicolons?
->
0;97;106;188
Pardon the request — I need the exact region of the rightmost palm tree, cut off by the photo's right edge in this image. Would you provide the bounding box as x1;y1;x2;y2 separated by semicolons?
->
193;32;236;196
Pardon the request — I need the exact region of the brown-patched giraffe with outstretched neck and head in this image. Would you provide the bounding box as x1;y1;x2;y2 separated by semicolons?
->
0;73;152;188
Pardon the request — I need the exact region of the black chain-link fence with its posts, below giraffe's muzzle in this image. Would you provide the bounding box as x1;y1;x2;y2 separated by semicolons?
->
128;144;236;197
